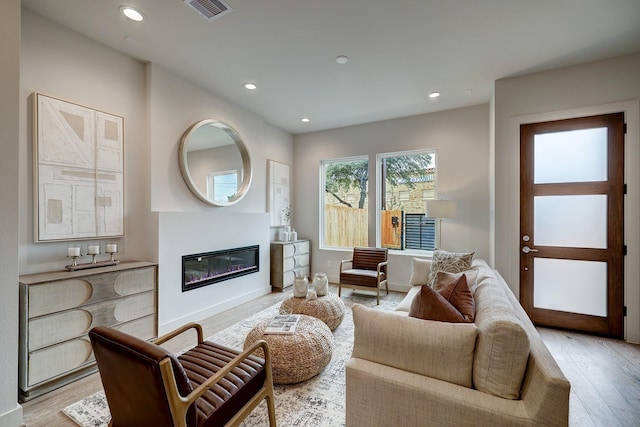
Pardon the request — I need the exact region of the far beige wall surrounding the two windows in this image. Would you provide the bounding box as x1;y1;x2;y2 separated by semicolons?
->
292;104;490;290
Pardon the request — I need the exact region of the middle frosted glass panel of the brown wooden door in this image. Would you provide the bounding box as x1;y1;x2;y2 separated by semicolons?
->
533;194;607;249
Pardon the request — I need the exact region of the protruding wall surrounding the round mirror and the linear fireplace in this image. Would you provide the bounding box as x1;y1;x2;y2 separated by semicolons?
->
147;64;293;333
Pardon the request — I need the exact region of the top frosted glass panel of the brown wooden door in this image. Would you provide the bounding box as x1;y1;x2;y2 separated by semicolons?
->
534;127;607;184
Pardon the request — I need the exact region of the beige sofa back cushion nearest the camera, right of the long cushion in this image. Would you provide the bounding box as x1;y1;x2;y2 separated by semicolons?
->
473;272;530;399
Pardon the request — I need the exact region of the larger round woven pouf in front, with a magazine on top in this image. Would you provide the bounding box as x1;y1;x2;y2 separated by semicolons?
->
244;316;333;384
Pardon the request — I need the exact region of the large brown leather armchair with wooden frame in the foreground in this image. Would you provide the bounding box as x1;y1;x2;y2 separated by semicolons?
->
89;323;276;427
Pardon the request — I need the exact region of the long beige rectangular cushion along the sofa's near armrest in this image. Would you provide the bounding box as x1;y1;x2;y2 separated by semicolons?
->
352;304;477;387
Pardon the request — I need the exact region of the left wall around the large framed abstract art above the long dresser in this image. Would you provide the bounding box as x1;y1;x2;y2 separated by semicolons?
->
20;9;154;274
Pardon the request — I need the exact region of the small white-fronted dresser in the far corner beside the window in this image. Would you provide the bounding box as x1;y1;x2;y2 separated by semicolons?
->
271;240;311;291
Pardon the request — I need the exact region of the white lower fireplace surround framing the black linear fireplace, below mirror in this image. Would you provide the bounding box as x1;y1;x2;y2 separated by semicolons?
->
158;209;271;335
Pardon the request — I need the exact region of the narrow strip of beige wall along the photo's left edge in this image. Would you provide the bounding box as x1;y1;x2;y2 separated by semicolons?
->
0;0;22;427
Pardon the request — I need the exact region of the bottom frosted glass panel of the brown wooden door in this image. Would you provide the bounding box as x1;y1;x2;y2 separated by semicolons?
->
533;258;607;317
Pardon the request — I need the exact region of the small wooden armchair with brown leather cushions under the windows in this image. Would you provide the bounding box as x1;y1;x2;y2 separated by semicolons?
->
338;247;389;304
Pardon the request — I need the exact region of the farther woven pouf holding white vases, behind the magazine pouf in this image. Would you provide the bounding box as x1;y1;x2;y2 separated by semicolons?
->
280;293;346;331
